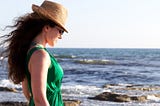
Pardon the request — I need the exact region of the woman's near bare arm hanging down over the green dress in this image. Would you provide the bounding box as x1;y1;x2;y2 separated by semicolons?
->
29;50;50;106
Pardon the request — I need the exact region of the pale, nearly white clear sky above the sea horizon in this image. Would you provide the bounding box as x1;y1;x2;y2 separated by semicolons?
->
0;0;160;48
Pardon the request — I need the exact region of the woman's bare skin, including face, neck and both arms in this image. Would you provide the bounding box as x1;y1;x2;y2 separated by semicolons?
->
22;25;62;106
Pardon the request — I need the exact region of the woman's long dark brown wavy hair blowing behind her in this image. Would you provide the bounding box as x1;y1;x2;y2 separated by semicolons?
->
0;13;56;84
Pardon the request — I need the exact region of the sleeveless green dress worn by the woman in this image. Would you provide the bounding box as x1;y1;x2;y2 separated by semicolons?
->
26;46;64;106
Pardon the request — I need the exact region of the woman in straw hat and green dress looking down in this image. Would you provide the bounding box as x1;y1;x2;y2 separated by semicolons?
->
0;0;67;106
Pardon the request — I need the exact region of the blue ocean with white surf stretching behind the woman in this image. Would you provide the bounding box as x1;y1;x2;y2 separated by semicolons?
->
0;48;160;106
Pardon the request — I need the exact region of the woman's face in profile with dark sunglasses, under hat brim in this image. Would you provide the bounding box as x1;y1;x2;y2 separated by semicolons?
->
46;26;64;47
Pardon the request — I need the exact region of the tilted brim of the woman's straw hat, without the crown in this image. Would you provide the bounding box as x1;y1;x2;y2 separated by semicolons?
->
32;4;68;33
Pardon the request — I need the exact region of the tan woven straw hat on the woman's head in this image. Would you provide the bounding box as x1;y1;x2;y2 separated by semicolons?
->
32;0;68;33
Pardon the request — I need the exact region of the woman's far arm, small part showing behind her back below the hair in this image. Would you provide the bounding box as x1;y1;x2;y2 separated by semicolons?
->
22;78;30;101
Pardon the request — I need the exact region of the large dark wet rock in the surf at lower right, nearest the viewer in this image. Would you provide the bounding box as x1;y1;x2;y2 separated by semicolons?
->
89;92;147;102
